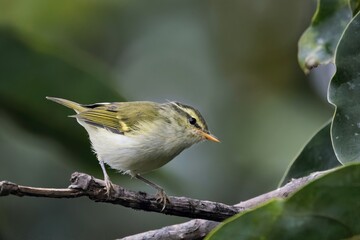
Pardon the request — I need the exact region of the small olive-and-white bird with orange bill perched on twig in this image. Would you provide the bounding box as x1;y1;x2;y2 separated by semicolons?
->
46;97;220;210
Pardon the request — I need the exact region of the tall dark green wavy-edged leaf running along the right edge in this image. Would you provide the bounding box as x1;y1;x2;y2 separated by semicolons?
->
329;10;360;163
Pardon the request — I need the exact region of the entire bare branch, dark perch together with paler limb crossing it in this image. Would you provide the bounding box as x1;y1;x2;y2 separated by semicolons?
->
0;170;331;240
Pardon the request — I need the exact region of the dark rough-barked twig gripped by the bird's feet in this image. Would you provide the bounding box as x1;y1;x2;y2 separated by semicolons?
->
0;172;241;221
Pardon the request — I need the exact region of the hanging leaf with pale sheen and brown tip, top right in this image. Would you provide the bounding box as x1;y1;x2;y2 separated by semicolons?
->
298;0;352;73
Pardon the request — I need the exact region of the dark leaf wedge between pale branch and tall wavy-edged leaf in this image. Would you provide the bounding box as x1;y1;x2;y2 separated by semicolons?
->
279;122;340;186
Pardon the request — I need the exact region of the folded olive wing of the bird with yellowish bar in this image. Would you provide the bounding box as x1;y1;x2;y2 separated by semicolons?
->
74;102;159;134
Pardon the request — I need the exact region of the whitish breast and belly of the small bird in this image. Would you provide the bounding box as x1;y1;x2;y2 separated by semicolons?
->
83;125;190;174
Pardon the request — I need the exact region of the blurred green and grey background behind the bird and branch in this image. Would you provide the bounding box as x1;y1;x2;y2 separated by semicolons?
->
0;0;332;239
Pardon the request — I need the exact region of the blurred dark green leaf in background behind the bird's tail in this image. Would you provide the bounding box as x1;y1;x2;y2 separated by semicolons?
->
0;29;123;168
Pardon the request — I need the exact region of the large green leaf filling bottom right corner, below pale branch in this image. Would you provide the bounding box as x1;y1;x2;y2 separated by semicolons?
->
207;164;360;240
